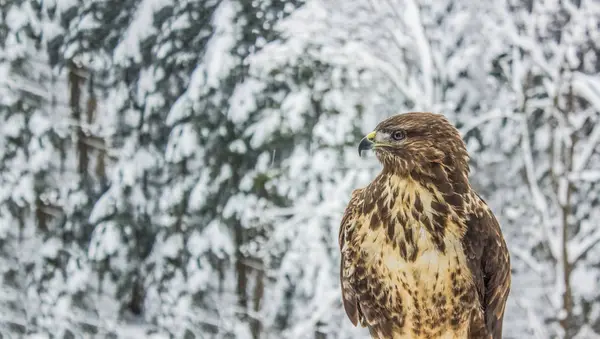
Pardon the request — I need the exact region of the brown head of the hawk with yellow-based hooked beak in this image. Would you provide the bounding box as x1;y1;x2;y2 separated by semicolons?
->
358;112;469;176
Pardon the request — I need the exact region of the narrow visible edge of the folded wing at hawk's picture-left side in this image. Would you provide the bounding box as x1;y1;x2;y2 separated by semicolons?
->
338;189;362;326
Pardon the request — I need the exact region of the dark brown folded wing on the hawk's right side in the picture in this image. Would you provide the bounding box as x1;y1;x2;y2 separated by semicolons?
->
465;196;511;339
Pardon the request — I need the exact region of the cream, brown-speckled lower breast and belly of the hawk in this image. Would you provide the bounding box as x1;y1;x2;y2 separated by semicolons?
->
357;214;476;338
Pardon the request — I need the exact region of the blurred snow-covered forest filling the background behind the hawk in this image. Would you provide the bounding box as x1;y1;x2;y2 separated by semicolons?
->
0;0;600;339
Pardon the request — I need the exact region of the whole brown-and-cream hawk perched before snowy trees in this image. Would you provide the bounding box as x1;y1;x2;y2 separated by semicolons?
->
339;112;511;339
